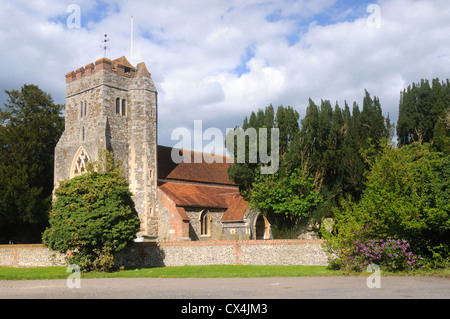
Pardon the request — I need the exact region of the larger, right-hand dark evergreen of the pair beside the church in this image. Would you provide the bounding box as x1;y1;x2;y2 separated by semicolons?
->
288;91;392;224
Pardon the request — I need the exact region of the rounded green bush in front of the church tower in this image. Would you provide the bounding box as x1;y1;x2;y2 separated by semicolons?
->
43;153;140;271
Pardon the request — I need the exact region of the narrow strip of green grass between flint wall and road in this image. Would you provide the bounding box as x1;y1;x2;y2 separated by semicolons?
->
0;265;450;280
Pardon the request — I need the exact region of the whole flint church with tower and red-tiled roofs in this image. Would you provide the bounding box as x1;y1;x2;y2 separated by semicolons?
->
54;57;271;241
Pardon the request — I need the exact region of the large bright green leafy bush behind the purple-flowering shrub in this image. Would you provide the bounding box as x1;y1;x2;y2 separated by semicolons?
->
324;142;450;266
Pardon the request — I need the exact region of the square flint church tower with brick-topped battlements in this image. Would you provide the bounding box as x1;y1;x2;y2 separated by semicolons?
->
55;57;158;236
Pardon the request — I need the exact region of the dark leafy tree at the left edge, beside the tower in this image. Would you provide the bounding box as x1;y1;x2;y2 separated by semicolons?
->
0;85;64;243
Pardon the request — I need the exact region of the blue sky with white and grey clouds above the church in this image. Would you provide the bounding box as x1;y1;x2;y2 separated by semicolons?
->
0;0;450;152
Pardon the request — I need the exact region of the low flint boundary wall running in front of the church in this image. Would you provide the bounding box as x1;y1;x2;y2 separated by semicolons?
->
0;239;328;267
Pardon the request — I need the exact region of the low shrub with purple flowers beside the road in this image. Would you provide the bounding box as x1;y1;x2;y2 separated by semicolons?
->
341;239;422;271
